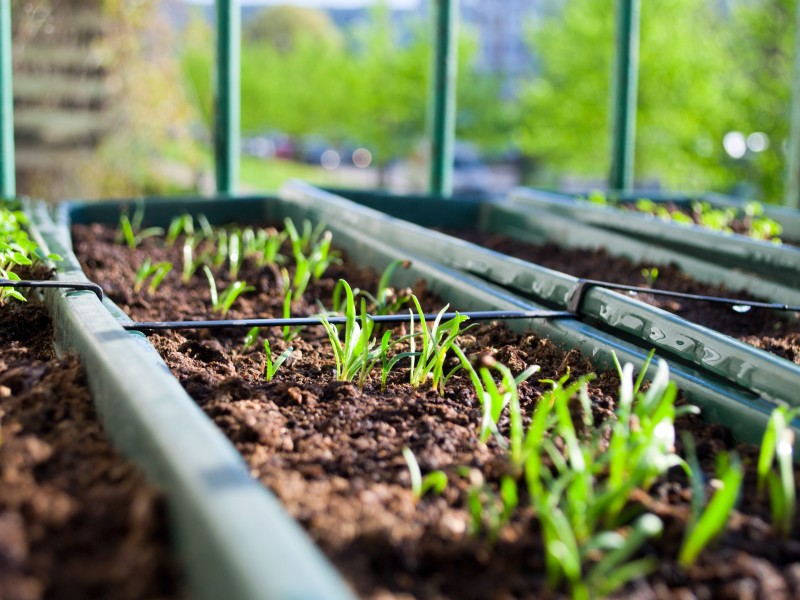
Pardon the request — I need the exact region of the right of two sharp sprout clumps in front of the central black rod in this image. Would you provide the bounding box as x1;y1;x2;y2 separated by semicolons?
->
409;294;469;394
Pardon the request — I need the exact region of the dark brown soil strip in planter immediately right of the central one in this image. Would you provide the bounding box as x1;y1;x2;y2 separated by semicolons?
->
449;231;800;364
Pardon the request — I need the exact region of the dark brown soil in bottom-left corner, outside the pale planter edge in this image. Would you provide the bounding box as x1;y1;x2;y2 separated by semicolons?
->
0;277;181;600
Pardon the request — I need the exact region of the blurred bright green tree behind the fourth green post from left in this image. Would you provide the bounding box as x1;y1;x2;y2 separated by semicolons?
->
517;0;741;190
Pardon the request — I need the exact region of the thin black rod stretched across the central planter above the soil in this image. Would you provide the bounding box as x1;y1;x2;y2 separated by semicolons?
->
122;310;575;331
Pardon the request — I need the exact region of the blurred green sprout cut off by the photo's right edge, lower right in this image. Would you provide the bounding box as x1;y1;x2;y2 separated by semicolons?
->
758;406;800;538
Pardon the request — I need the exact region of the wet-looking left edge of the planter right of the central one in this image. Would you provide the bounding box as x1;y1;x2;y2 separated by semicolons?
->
284;184;800;412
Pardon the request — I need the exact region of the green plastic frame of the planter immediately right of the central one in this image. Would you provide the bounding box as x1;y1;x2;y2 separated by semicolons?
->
284;183;800;432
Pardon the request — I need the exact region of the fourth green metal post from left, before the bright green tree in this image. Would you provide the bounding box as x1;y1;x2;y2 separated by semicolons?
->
609;0;641;190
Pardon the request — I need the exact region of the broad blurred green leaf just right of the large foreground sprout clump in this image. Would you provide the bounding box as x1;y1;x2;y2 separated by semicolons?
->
678;452;744;567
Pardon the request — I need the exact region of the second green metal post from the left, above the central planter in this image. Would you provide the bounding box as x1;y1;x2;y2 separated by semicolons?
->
214;0;242;194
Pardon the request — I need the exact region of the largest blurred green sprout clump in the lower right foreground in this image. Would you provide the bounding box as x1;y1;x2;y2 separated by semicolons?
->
522;361;688;599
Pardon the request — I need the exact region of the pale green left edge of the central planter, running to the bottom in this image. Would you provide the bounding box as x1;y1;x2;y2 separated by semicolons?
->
27;203;354;600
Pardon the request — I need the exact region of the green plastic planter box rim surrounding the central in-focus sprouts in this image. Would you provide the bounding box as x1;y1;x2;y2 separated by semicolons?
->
32;188;800;598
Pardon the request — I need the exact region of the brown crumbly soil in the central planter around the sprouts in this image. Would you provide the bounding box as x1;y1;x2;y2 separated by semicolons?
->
73;226;800;599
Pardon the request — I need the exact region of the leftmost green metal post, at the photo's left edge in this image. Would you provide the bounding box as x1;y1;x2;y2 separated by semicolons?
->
0;0;17;198
